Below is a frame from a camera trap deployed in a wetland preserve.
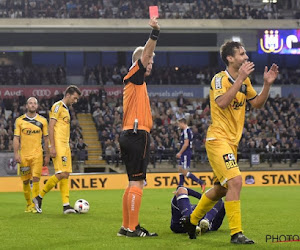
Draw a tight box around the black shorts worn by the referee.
[120,129,150,181]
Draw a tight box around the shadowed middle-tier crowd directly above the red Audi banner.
[0,65,300,86]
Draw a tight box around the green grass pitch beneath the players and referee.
[0,186,300,249]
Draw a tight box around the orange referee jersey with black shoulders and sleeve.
[123,60,153,132]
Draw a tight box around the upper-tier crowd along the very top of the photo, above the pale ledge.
[0,0,288,19]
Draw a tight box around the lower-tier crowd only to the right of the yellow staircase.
[92,93,300,163]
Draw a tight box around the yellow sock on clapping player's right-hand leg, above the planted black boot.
[224,201,243,235]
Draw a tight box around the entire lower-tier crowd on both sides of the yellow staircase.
[0,92,300,164]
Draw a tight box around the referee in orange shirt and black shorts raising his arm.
[117,17,160,237]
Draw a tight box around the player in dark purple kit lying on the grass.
[170,186,225,233]
